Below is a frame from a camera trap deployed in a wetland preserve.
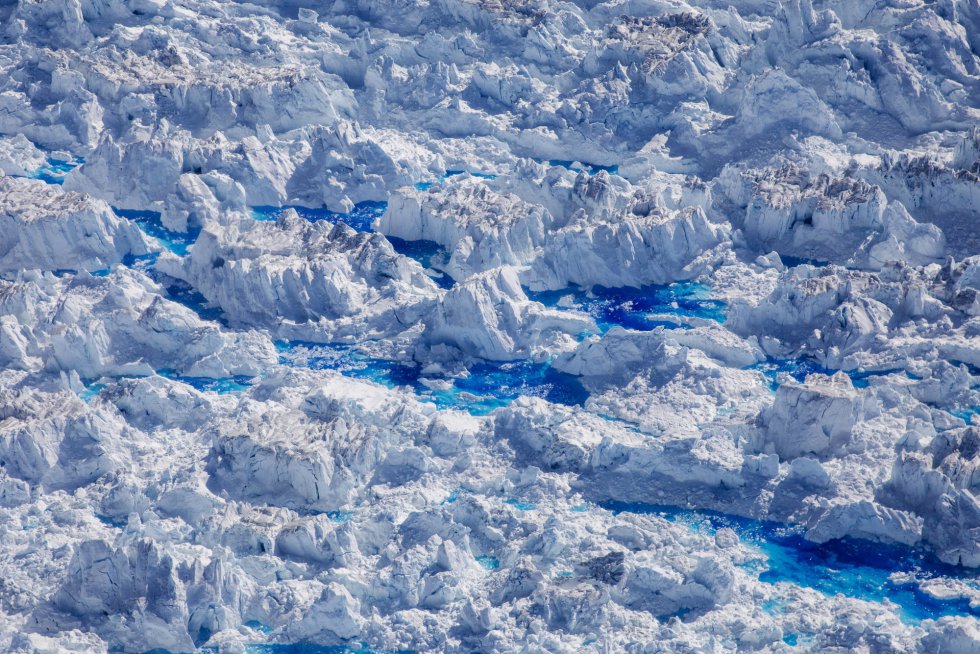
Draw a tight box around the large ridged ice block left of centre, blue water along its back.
[162,210,436,340]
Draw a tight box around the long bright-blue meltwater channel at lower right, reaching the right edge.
[601,502,980,623]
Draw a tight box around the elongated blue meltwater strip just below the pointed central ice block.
[276,341,588,415]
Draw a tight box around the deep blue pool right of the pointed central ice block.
[524,282,726,333]
